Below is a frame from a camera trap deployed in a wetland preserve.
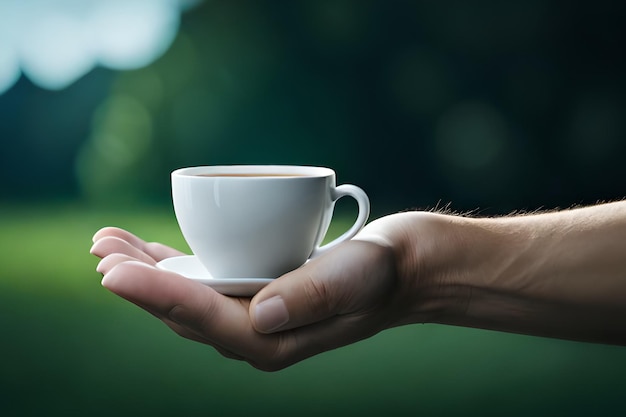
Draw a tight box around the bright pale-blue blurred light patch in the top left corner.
[0,0,196,94]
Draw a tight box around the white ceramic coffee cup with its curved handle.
[171,165,370,278]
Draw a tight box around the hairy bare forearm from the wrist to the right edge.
[403,202,626,344]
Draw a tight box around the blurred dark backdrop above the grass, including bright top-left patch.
[0,0,626,214]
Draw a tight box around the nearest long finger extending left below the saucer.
[102,261,276,357]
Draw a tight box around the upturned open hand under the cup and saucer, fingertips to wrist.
[91,216,404,370]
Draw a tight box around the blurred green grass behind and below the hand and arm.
[0,204,626,416]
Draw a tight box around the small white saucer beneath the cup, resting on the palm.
[157,255,272,297]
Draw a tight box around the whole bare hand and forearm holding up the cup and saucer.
[91,202,626,371]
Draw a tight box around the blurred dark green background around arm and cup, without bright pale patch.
[0,0,626,416]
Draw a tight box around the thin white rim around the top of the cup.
[171,165,335,179]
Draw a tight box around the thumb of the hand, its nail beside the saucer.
[249,241,387,333]
